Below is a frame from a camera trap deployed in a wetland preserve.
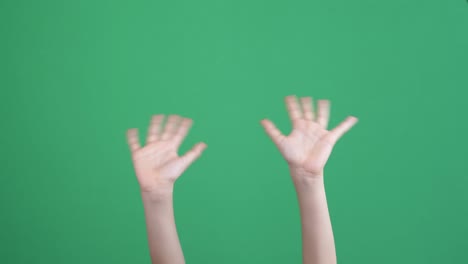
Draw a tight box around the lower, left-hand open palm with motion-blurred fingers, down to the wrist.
[127,115,206,192]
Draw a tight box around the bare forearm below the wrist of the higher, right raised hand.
[293,176,336,264]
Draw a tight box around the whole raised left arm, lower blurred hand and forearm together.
[127,115,206,264]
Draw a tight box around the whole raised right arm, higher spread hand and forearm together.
[262,96,357,264]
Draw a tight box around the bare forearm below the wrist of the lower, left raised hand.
[142,188,185,264]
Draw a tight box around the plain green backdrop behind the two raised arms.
[0,0,468,264]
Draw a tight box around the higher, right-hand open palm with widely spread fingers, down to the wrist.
[261,96,357,178]
